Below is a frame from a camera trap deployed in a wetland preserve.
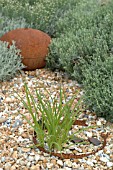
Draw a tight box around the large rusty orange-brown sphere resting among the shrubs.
[0,28,51,70]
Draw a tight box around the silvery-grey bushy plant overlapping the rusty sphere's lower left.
[0,41,24,81]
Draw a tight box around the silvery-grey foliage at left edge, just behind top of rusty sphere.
[0,14,32,37]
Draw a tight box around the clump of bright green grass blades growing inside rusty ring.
[18,83,92,151]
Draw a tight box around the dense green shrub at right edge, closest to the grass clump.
[83,54,113,122]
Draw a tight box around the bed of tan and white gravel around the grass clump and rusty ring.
[0,69,113,170]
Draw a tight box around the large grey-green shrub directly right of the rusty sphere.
[47,0,113,82]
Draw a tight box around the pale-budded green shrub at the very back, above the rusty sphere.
[0,0,78,36]
